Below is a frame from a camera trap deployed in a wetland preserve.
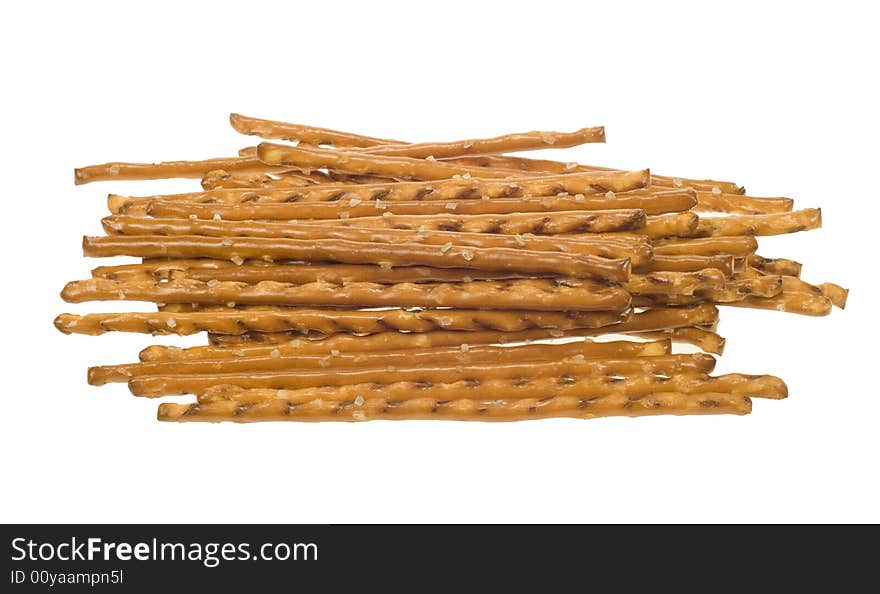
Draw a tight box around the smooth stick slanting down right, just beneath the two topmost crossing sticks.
[257,142,525,180]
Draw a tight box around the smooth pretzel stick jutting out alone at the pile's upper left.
[73,157,289,185]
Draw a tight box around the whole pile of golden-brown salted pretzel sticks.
[55,114,847,422]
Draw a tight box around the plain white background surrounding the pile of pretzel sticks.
[0,0,880,522]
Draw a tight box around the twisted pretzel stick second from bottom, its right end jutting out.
[198,373,788,404]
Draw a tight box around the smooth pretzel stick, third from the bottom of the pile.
[128,354,715,398]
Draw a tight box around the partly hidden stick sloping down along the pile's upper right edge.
[447,155,745,194]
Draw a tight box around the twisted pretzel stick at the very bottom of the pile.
[157,392,752,423]
